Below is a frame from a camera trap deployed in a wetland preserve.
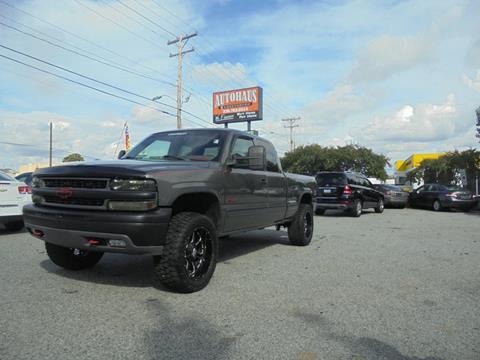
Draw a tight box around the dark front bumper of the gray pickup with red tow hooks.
[23,205,172,254]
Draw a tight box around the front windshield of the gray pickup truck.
[122,130,226,161]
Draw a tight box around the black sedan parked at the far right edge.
[408,184,478,211]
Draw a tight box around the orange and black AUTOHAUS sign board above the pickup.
[213,86,263,124]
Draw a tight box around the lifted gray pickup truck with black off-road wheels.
[23,129,315,292]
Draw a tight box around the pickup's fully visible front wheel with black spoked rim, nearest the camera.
[154,212,218,293]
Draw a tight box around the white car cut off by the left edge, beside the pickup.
[0,171,32,231]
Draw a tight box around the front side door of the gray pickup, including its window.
[225,135,267,231]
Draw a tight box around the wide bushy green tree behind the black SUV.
[282,144,389,180]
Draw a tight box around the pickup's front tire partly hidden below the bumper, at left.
[45,243,103,270]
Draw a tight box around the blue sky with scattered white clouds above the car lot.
[0,0,480,173]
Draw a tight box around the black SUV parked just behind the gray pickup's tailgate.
[315,171,384,217]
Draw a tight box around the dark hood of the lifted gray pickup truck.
[34,160,216,178]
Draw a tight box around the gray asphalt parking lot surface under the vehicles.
[0,209,480,360]
